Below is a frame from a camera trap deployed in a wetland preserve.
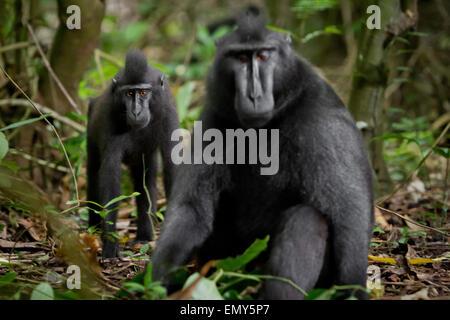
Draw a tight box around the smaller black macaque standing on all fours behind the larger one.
[87,50,178,258]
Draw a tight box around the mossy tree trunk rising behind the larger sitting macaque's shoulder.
[349,0,418,196]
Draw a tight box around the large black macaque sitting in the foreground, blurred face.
[153,10,373,299]
